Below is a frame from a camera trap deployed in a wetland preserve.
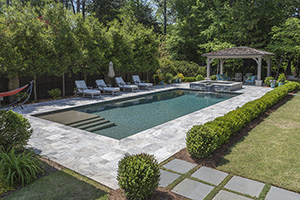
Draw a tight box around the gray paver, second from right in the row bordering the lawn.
[225,176,265,197]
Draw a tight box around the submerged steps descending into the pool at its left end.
[66,116,115,132]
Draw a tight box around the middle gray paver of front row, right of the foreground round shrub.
[172,179,214,200]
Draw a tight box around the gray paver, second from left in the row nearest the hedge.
[192,167,228,185]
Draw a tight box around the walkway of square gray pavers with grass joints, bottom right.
[159,159,300,200]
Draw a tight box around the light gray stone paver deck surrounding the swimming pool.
[15,83,271,189]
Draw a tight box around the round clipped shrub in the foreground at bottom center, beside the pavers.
[117,153,160,200]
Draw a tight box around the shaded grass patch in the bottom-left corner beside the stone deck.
[7,169,109,200]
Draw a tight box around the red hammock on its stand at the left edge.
[0,81,34,109]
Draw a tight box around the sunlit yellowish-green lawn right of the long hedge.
[217,96,300,192]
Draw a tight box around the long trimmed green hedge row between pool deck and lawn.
[186,82,300,158]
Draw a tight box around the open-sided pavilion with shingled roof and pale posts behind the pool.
[202,47,275,80]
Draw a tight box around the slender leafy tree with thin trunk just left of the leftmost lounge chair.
[40,3,79,96]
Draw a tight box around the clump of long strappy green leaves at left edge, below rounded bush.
[0,148,43,186]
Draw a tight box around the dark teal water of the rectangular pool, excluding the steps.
[76,90,237,139]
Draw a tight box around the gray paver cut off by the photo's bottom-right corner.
[266,186,300,200]
